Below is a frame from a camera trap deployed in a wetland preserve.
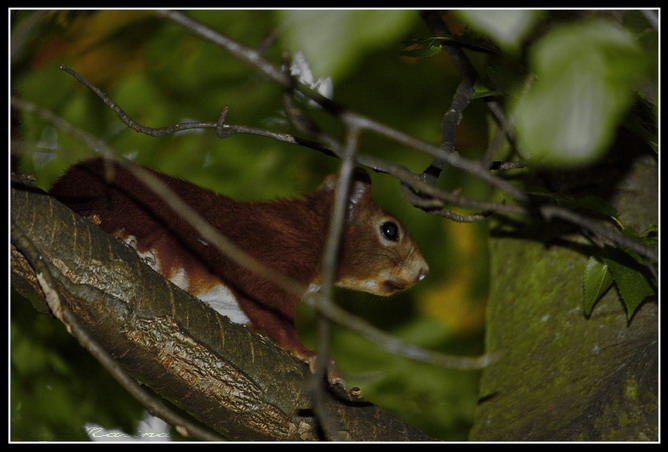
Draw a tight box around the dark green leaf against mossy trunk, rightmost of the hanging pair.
[603,249,656,319]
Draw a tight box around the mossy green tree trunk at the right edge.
[470,144,658,441]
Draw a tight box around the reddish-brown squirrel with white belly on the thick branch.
[49,158,429,383]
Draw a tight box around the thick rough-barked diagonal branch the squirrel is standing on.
[11,180,429,441]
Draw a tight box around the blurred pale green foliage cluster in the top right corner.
[458,11,658,167]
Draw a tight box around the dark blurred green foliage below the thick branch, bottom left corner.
[9,293,143,441]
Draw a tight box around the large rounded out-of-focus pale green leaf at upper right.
[513,20,649,166]
